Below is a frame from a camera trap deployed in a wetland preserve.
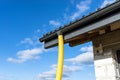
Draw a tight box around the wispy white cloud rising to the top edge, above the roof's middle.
[71,0,91,20]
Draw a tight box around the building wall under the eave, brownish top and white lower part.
[92,30,120,80]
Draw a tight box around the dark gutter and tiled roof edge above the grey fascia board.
[39,1,120,42]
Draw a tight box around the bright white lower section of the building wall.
[94,58,116,80]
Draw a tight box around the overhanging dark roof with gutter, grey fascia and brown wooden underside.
[40,1,120,48]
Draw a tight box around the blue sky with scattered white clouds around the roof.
[0,0,115,80]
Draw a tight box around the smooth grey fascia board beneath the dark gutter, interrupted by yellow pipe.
[44,11,120,49]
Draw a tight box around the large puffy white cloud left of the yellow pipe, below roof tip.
[7,48,45,63]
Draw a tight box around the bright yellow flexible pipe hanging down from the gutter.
[56,35,64,80]
